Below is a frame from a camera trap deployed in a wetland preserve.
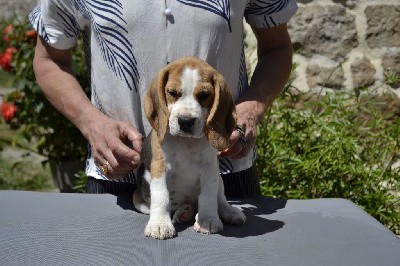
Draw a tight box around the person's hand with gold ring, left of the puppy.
[88,113,143,179]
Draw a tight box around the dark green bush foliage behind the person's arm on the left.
[0,19,89,161]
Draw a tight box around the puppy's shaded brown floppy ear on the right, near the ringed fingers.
[205,73,236,151]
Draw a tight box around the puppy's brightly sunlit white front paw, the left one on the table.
[144,217,176,239]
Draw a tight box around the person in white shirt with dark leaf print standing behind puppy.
[30,0,297,197]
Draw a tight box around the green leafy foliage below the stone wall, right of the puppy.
[257,90,400,234]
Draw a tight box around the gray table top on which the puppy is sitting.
[0,191,400,265]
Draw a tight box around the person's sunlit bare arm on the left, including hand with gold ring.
[33,37,143,178]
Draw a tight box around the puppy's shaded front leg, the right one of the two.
[193,161,223,234]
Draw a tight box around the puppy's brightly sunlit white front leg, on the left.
[145,171,176,239]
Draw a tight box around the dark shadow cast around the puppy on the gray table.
[117,195,287,238]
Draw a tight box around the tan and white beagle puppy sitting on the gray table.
[133,57,246,239]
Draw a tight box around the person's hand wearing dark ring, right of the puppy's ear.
[219,101,258,159]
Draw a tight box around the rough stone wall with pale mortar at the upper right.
[246,0,400,95]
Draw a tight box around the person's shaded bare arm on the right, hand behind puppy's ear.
[220,24,292,159]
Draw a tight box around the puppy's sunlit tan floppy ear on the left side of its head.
[144,67,169,143]
